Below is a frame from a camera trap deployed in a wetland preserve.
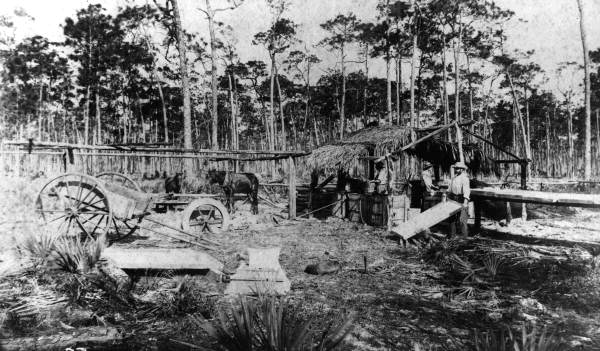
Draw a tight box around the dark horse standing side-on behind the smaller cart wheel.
[206,169,258,214]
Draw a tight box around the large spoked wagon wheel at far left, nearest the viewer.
[36,173,113,239]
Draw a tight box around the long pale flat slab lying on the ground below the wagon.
[102,247,223,273]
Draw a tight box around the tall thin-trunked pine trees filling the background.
[0,0,600,178]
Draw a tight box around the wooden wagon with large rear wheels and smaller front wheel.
[36,173,230,243]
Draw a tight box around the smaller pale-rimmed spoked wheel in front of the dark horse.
[181,199,231,234]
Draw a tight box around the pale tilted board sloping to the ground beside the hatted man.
[391,200,462,240]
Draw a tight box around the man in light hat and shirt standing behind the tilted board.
[448,162,471,237]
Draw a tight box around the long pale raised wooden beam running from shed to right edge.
[471,188,600,207]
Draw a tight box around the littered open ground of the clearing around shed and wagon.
[0,178,600,350]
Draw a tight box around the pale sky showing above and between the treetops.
[0,0,600,92]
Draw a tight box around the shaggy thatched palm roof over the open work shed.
[307,126,497,174]
